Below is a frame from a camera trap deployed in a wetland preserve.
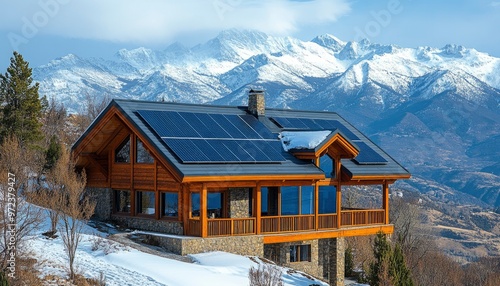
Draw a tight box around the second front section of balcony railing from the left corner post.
[261,215,314,233]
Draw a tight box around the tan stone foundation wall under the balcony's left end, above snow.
[146,232,264,257]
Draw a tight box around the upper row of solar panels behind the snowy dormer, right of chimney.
[273,117,359,140]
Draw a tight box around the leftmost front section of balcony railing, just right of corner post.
[208,218,255,236]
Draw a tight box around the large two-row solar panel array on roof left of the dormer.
[137,110,286,163]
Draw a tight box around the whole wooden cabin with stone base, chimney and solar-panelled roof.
[72,90,410,285]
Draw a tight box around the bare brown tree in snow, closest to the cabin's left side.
[47,150,95,280]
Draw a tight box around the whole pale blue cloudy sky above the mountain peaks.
[0,0,500,69]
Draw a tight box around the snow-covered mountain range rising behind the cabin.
[34,30,500,207]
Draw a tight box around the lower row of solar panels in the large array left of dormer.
[163,138,286,163]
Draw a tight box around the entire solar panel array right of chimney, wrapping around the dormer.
[272,117,388,165]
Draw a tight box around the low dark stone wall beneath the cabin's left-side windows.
[111,215,184,235]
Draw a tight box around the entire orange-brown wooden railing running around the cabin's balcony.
[187,209,385,237]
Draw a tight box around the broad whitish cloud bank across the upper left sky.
[0,0,350,43]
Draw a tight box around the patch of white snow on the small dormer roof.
[279,130,332,151]
